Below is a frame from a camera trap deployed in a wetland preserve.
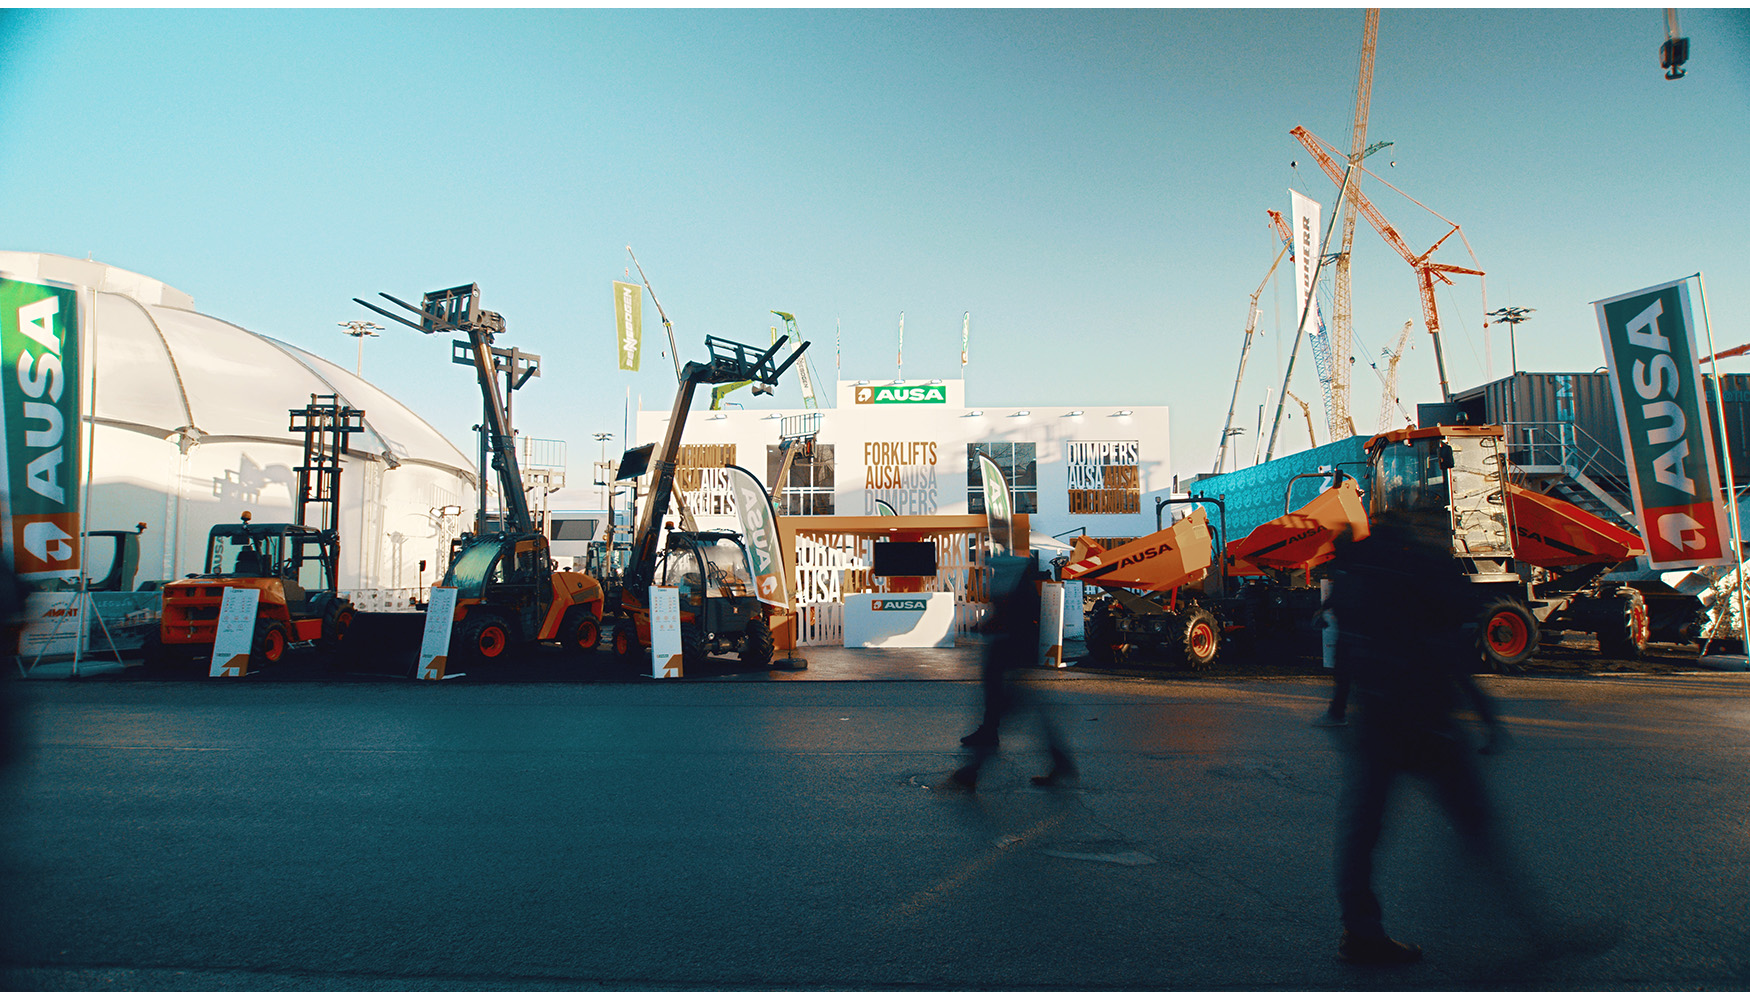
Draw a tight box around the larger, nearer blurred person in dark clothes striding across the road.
[1330,524,1537,965]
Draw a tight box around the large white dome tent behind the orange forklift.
[0,250,476,592]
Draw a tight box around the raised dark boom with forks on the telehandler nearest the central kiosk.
[620,336,809,592]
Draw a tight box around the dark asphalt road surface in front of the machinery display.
[0,674,1750,989]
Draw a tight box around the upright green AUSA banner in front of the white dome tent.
[0,278,84,578]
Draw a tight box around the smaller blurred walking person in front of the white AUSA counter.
[949,555,1076,792]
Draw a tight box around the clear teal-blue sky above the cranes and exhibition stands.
[0,9,1750,482]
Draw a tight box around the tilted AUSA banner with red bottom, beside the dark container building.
[1593,282,1731,569]
